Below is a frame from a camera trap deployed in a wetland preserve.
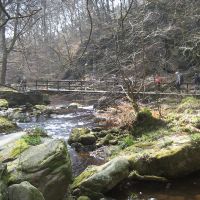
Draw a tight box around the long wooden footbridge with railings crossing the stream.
[17,80,200,97]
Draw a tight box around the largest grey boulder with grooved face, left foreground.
[7,140,72,200]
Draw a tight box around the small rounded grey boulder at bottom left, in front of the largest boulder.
[8,181,44,200]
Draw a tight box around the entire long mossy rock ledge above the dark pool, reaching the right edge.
[72,133,200,200]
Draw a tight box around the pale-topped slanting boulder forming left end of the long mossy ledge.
[72,157,129,200]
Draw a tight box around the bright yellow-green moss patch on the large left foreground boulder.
[10,139,29,158]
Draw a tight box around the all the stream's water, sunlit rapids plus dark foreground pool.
[1,106,200,200]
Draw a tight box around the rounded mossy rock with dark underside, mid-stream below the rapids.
[68,128,96,145]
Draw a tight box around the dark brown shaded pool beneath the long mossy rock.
[109,172,200,200]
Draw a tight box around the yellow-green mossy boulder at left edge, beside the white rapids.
[0,117,19,133]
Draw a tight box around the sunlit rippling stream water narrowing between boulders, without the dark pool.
[18,106,103,175]
